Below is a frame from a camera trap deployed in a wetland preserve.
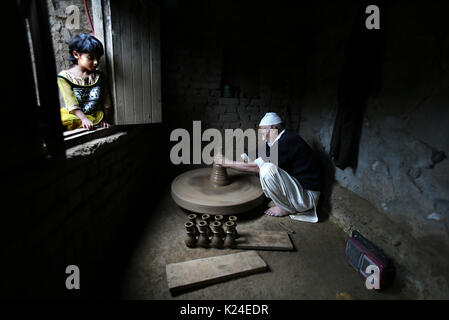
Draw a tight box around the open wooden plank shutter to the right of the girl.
[92,0,162,125]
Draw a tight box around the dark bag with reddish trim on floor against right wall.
[345,230,395,289]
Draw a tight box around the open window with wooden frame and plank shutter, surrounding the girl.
[18,0,162,151]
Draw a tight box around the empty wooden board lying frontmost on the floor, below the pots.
[166,251,268,293]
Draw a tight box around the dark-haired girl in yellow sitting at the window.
[58,33,111,130]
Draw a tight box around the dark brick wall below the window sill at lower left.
[0,126,161,297]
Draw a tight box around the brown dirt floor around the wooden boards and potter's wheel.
[116,188,415,300]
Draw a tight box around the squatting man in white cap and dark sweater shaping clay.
[215,112,322,222]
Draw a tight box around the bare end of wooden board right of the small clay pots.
[236,227,294,251]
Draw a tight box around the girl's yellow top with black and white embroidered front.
[58,70,111,114]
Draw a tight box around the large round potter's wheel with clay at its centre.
[171,164,264,215]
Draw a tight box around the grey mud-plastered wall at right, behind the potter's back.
[300,1,449,297]
